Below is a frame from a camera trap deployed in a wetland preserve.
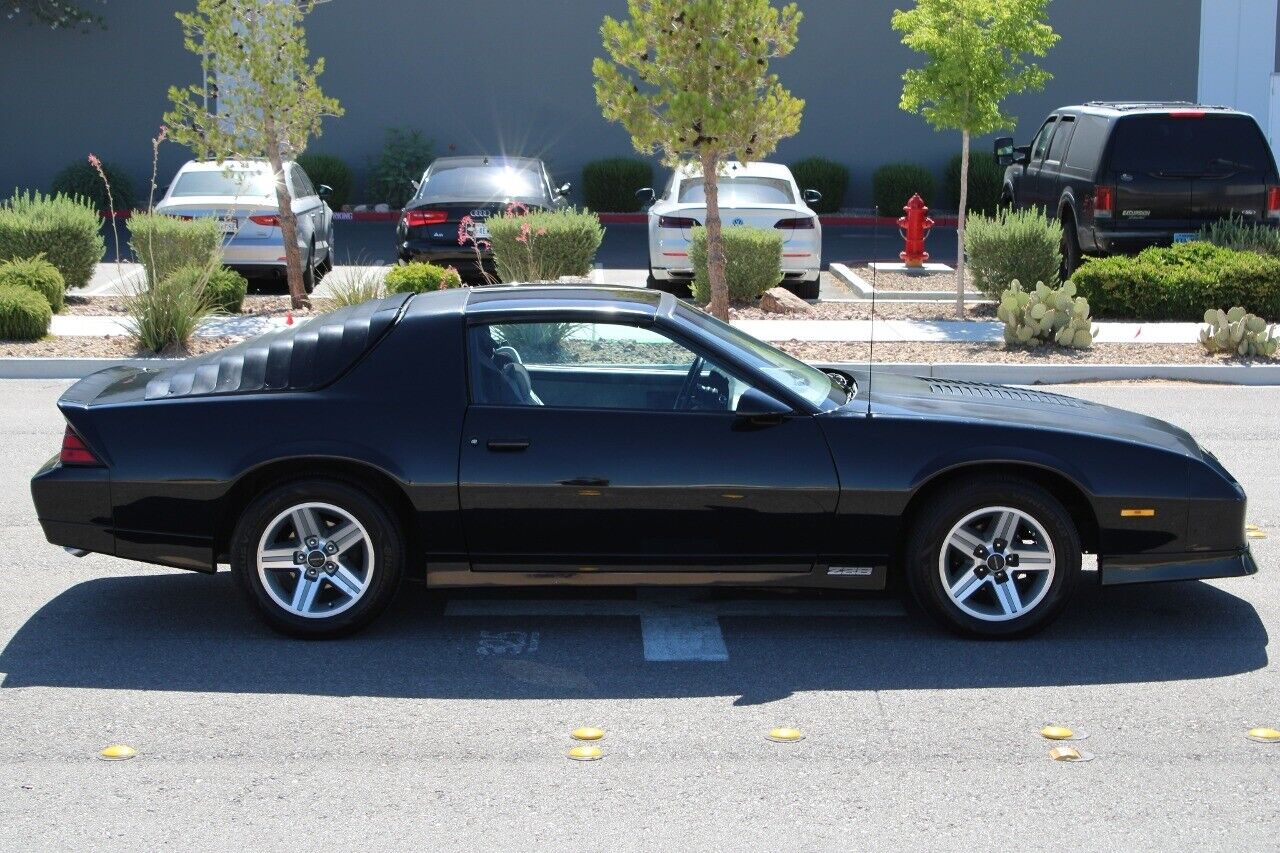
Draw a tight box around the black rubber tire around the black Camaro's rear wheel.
[230,479,404,639]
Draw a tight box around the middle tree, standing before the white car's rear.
[591,0,804,320]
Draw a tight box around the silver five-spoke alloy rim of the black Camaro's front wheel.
[938,506,1057,622]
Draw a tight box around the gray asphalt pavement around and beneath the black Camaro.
[0,380,1280,850]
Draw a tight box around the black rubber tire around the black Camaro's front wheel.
[904,476,1080,638]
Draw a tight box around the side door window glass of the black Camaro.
[467,323,749,411]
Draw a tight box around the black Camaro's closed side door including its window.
[458,320,838,573]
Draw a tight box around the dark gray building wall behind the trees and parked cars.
[0,0,1201,204]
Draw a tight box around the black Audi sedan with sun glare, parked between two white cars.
[396,156,570,280]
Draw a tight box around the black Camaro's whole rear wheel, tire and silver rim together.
[232,479,404,639]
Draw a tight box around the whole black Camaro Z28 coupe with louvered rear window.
[32,286,1257,637]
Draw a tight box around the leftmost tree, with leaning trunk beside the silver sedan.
[164,0,342,309]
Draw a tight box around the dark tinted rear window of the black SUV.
[1111,115,1272,175]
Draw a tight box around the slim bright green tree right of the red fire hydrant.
[893,0,1059,318]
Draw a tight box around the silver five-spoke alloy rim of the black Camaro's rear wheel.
[257,502,374,619]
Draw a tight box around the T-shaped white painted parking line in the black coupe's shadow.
[444,589,906,661]
